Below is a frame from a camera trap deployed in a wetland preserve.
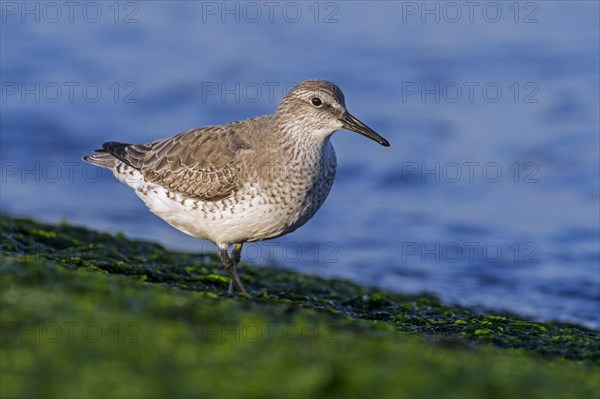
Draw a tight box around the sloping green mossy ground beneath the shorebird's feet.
[0,217,600,397]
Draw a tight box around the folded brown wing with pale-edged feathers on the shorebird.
[102,118,265,201]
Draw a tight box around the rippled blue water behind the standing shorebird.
[0,1,600,329]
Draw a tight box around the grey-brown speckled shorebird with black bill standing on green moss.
[83,80,389,296]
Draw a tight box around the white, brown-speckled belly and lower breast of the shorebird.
[113,141,336,245]
